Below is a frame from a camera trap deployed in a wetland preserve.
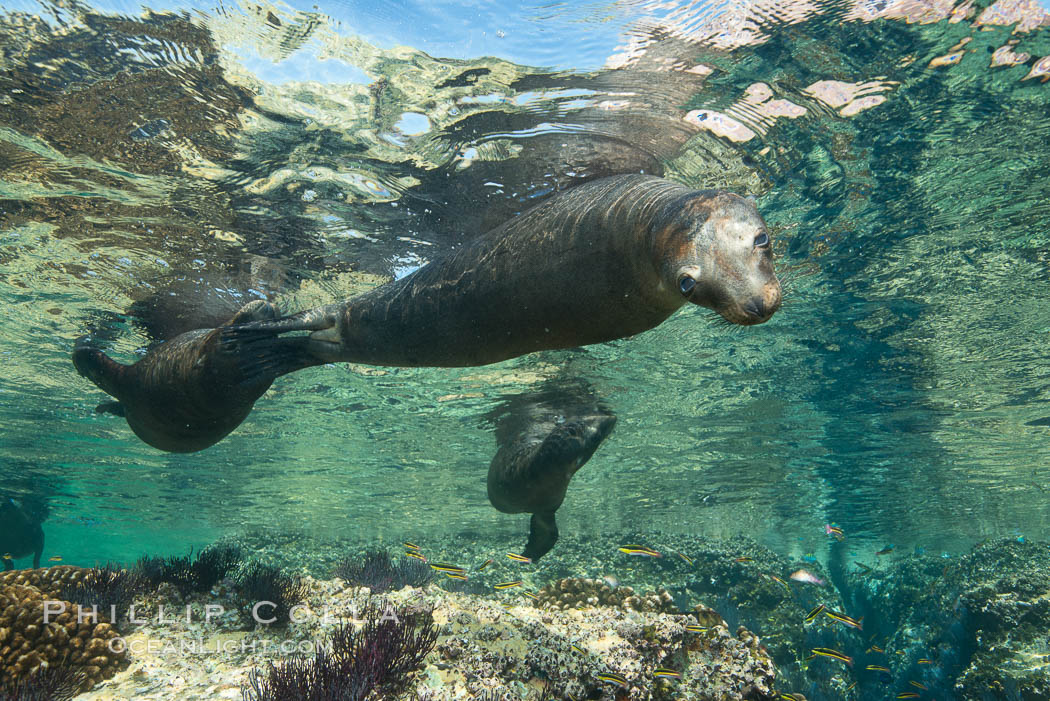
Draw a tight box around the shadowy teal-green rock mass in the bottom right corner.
[857,538,1050,701]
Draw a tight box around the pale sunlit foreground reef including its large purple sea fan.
[59,577,775,701]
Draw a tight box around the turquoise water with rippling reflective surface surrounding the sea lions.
[0,2,1050,696]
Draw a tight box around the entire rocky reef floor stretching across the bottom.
[0,536,1050,701]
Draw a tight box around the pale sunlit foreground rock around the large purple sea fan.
[59,577,776,701]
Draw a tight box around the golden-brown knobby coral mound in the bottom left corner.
[0,570,125,688]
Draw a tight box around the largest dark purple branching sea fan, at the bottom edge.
[243,602,438,701]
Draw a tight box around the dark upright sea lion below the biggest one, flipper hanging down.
[488,384,616,562]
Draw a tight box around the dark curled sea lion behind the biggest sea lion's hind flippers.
[72,300,302,452]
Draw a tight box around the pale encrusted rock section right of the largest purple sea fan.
[435,587,775,701]
